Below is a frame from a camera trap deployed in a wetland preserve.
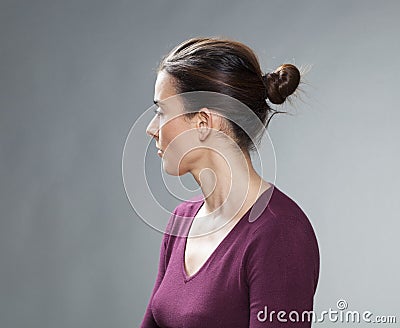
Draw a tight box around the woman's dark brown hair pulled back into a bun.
[157,37,300,150]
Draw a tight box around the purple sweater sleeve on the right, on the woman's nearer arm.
[246,218,319,328]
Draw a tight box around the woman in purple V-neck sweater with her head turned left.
[141,38,319,328]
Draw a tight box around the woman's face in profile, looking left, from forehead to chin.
[146,71,201,175]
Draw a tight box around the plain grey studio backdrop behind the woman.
[0,0,400,328]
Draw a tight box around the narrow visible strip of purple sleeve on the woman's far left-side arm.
[140,209,176,328]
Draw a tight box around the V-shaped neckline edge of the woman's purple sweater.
[181,182,276,283]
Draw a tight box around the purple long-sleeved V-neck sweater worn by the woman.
[140,183,319,328]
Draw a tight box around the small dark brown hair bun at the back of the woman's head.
[263,64,300,105]
